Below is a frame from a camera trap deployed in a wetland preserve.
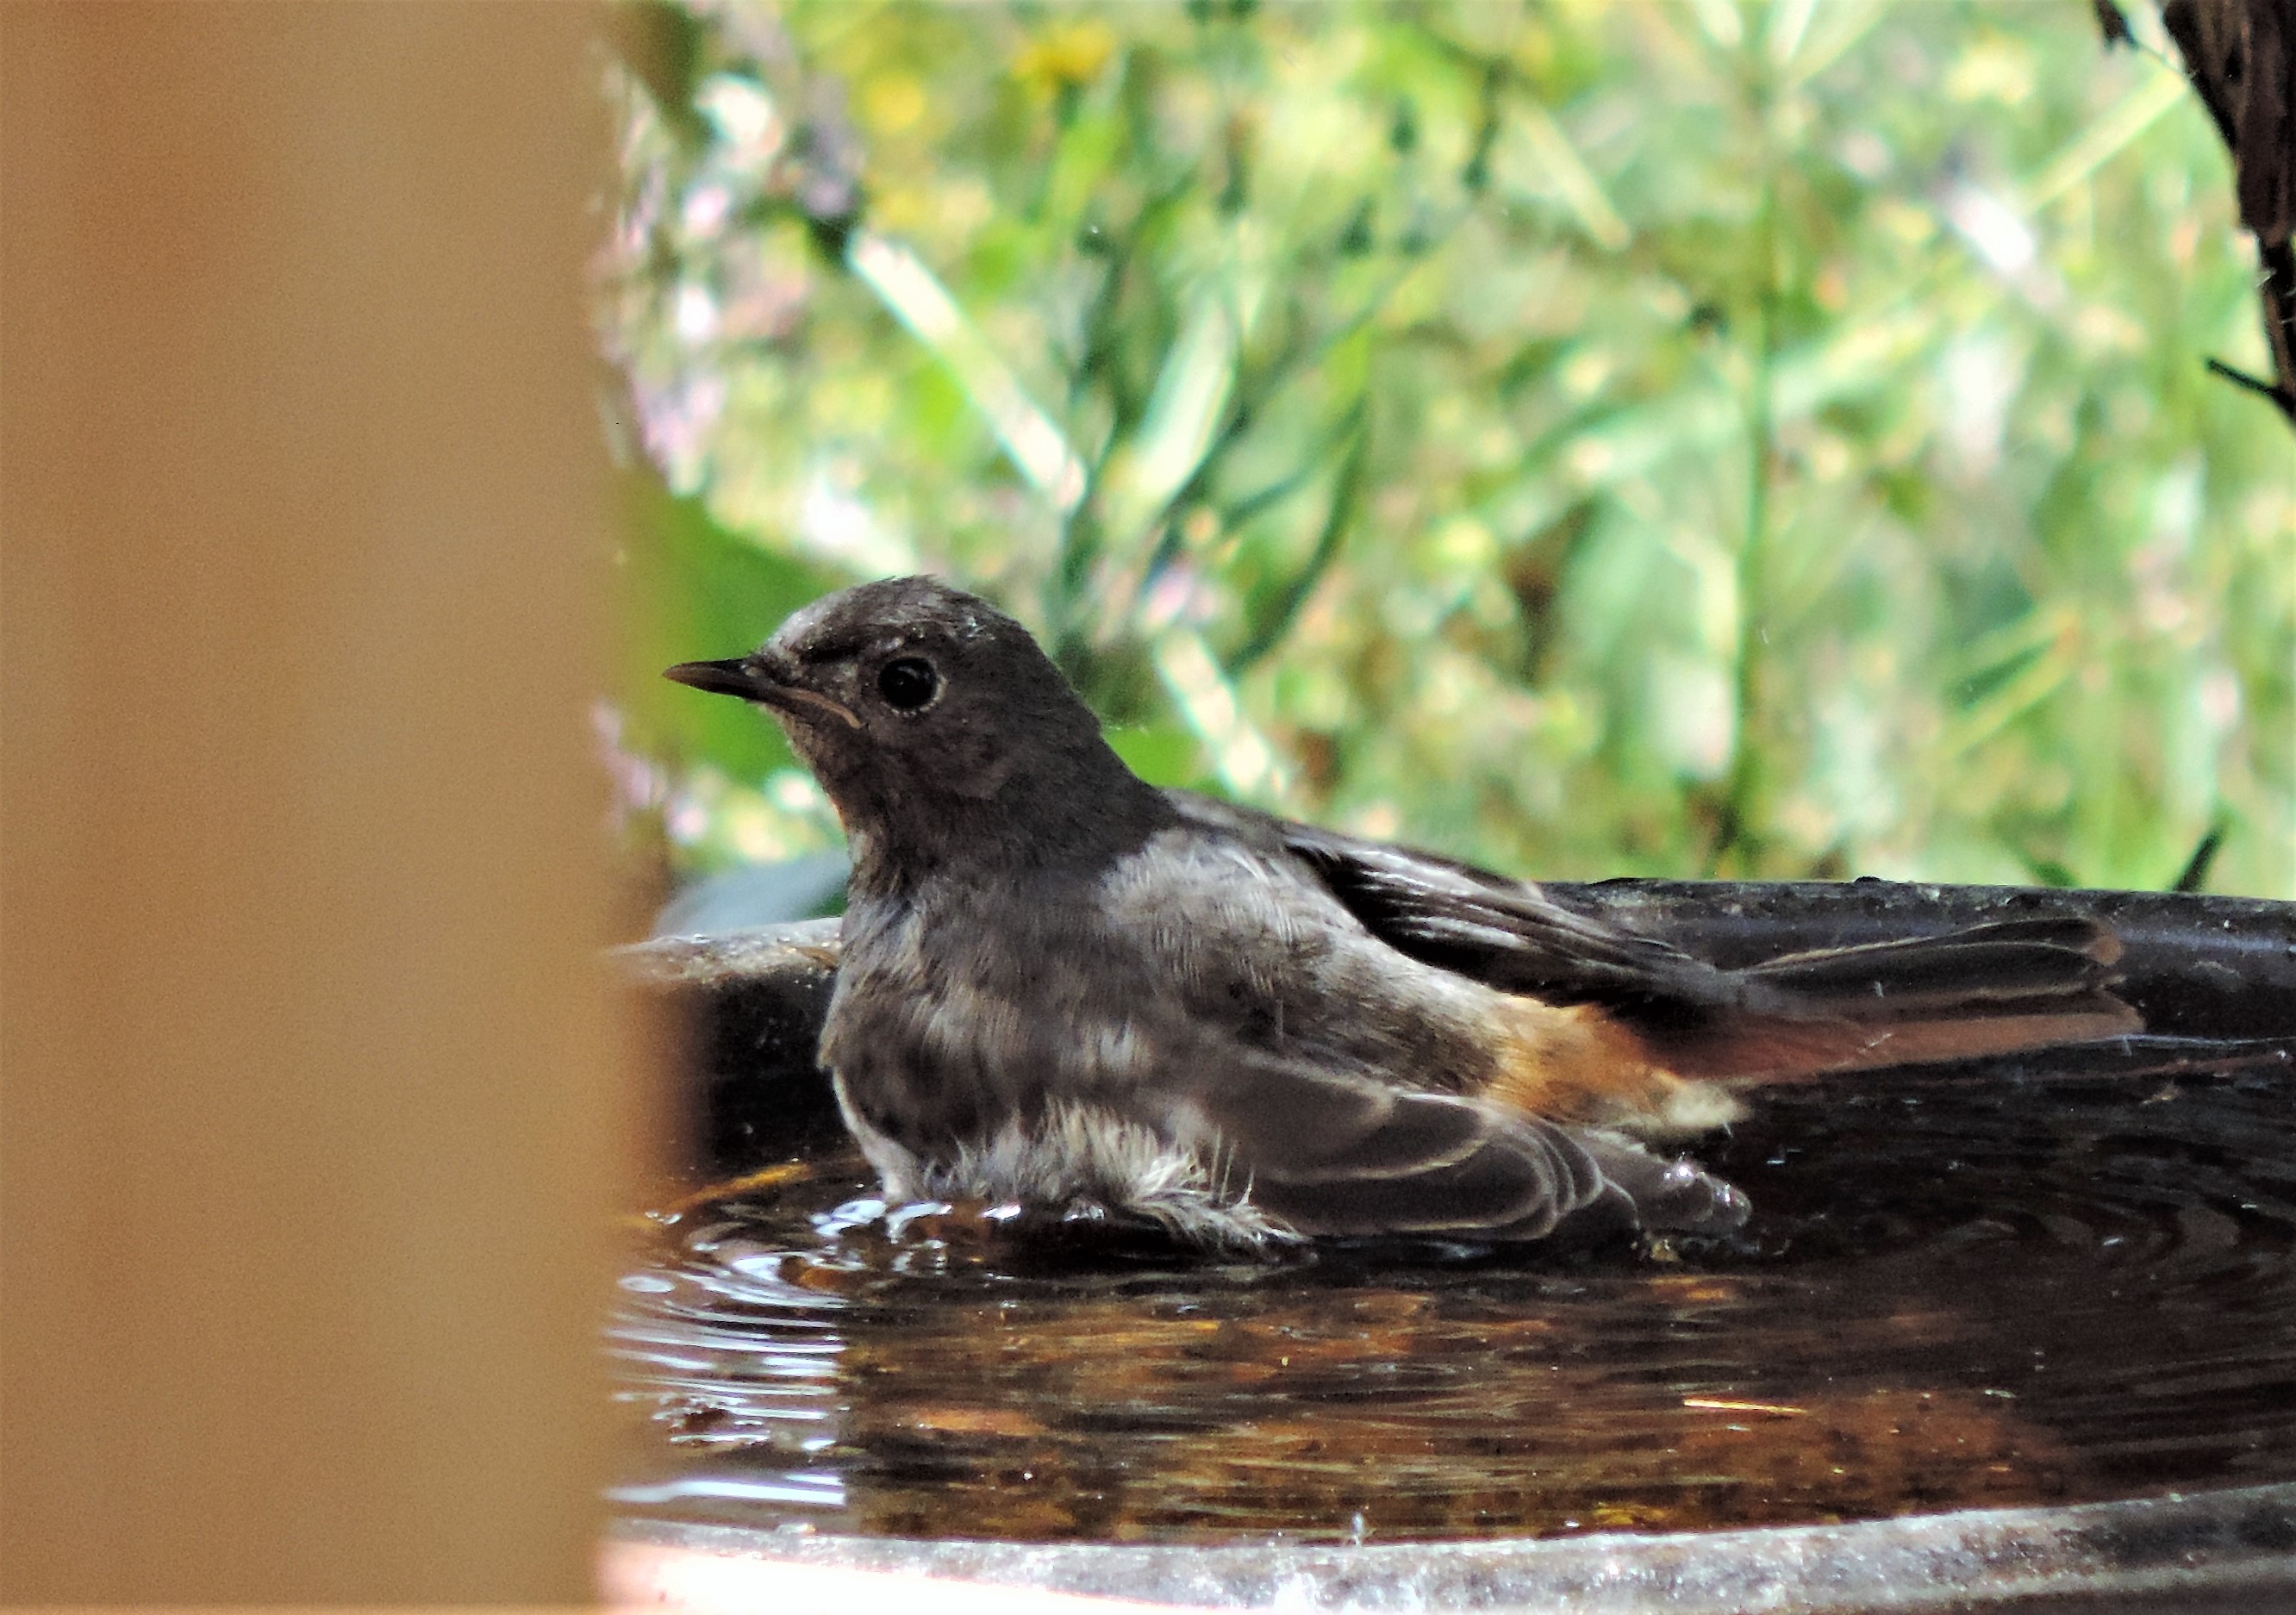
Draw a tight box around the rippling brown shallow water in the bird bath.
[608,1066,2296,1542]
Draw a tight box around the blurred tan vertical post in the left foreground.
[0,4,636,1604]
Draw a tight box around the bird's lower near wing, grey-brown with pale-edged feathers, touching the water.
[1192,1057,1745,1238]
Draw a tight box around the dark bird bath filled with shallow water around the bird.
[608,882,2296,1611]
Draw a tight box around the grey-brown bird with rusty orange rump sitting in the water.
[666,577,2143,1256]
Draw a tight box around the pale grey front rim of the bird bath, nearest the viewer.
[604,1484,2296,1615]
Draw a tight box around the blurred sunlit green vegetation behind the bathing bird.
[602,0,2296,914]
